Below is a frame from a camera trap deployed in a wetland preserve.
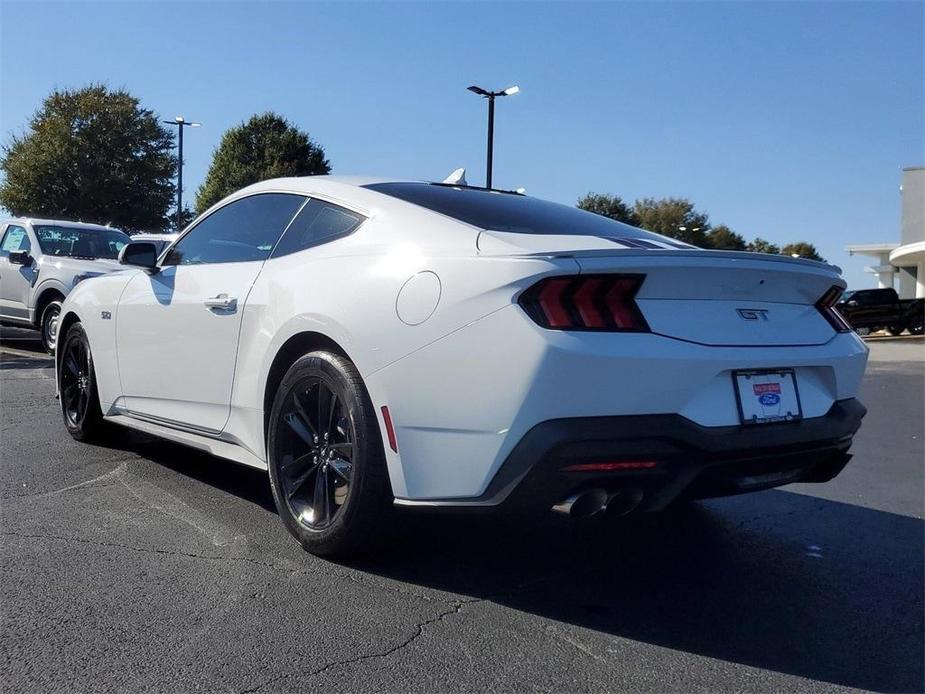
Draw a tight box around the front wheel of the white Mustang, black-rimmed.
[58,323,108,441]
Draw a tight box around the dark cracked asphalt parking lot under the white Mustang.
[0,329,925,692]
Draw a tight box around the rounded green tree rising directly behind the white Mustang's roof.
[196,111,331,213]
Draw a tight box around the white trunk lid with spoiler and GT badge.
[479,232,845,347]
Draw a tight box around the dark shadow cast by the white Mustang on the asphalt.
[352,491,925,691]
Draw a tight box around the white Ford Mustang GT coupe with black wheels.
[57,176,867,554]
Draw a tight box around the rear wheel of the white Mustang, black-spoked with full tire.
[267,352,392,556]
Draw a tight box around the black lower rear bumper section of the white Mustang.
[396,398,867,511]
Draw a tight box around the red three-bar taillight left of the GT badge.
[519,275,649,332]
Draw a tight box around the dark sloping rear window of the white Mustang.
[364,183,691,248]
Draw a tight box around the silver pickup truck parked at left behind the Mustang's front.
[0,219,130,352]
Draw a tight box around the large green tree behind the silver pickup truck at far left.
[0,85,177,230]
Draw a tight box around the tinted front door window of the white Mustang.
[163,193,305,265]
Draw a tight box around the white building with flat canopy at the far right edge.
[845,166,925,299]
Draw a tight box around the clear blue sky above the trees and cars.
[0,0,925,286]
